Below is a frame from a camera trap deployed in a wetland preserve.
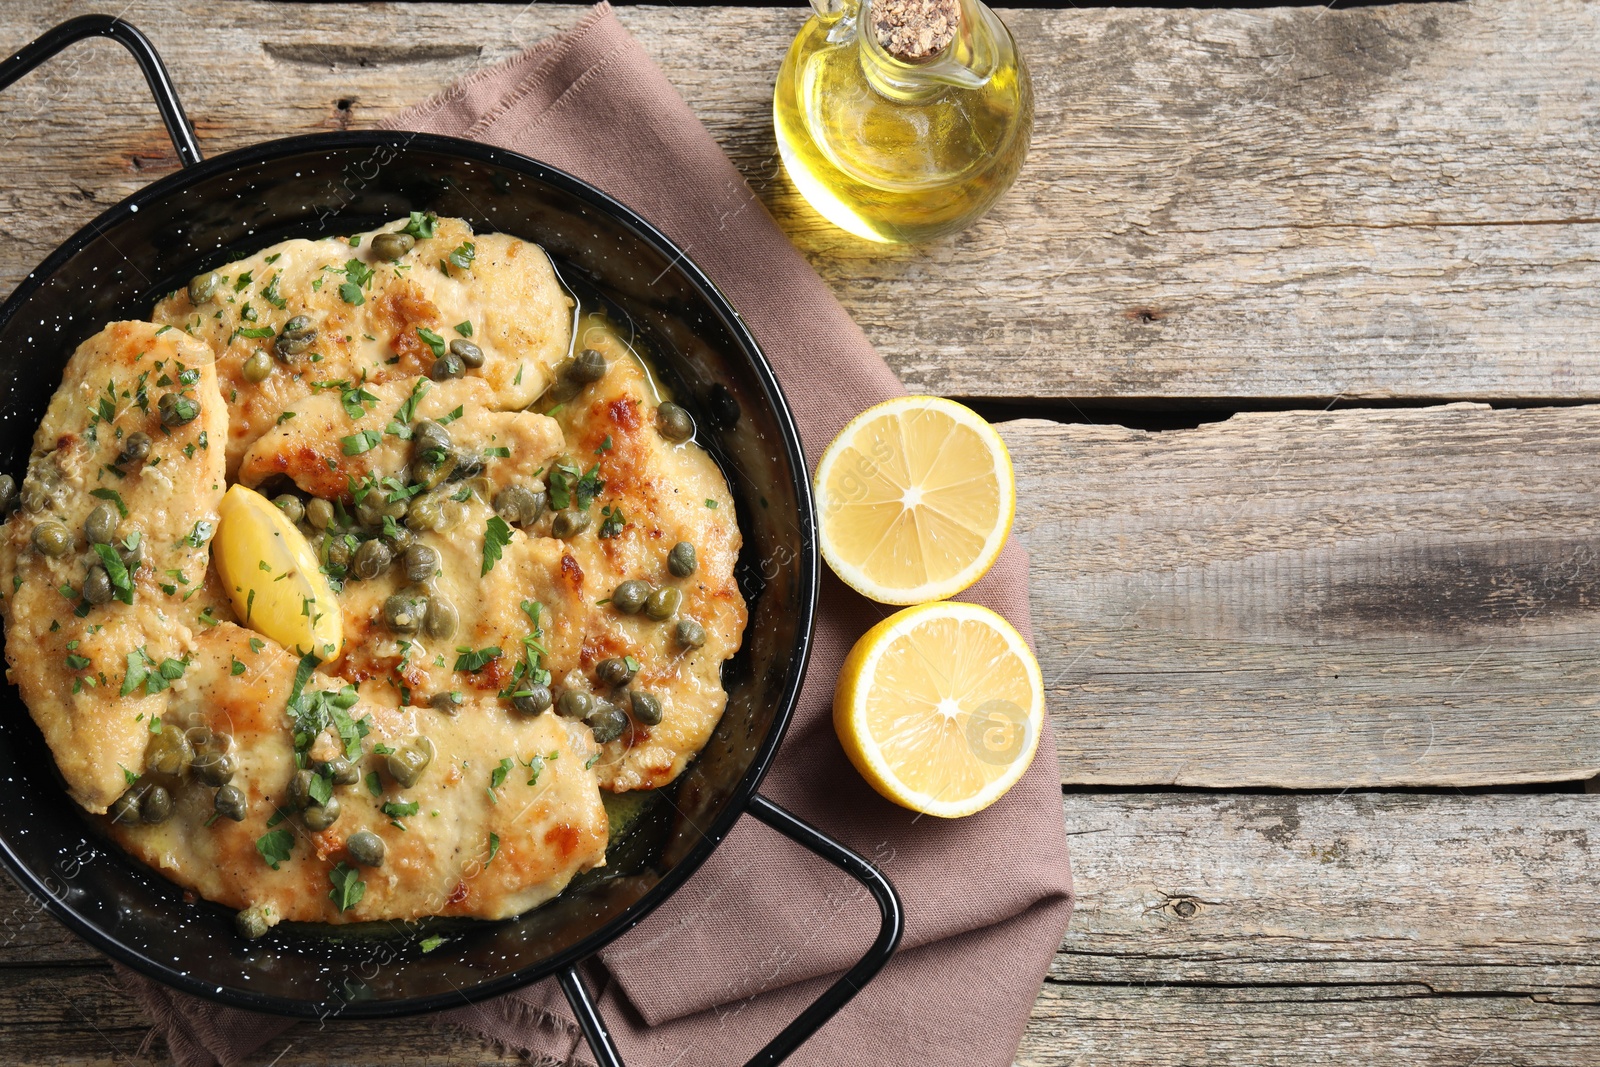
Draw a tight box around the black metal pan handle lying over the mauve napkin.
[557,793,906,1067]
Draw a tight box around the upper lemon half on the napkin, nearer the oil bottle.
[816,397,1016,605]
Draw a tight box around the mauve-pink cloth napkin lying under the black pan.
[120,3,1072,1067]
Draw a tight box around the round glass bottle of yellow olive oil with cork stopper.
[773,0,1034,242]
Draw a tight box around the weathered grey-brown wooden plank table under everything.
[0,0,1600,1067]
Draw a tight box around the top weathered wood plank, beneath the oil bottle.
[0,0,1600,403]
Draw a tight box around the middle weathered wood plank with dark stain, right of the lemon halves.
[1002,405,1600,789]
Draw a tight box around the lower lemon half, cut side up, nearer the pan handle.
[834,601,1045,819]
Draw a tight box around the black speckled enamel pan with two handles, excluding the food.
[0,14,902,1067]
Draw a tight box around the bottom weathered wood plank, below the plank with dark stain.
[12,793,1600,1067]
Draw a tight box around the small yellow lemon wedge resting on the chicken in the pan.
[211,485,344,662]
